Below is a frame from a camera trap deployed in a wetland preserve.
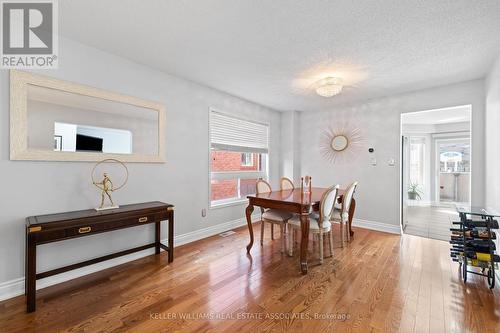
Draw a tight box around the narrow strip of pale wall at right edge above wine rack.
[485,53,500,212]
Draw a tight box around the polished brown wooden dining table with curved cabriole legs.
[246,187,356,274]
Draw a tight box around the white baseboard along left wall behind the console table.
[0,215,260,301]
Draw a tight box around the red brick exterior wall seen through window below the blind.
[210,151,260,200]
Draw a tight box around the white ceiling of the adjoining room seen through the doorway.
[401,105,471,125]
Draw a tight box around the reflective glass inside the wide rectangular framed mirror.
[27,85,159,155]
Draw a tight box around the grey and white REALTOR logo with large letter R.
[0,0,58,69]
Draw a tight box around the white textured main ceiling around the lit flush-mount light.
[59,0,500,111]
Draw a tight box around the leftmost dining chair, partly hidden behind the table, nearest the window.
[256,179,293,253]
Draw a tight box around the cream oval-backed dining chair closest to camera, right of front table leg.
[288,185,339,264]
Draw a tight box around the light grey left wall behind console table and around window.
[0,38,281,290]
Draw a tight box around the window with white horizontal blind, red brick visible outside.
[210,110,269,207]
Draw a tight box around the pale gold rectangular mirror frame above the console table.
[10,70,165,163]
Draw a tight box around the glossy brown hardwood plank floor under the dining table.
[0,224,500,333]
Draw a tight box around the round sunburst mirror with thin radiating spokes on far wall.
[320,123,364,163]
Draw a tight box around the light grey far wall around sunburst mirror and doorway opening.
[292,80,484,225]
